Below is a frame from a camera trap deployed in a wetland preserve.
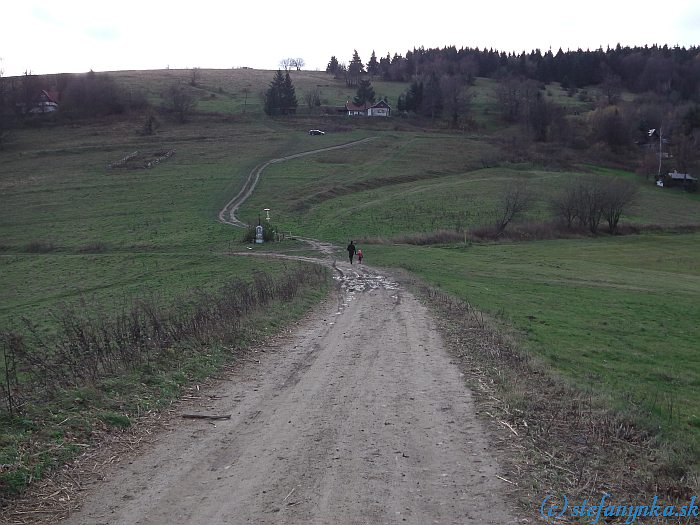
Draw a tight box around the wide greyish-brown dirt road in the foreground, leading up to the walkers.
[64,263,518,525]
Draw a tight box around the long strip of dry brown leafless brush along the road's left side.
[0,265,326,412]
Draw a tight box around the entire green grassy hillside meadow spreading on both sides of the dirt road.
[0,65,700,512]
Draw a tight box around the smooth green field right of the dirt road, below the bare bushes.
[364,234,700,458]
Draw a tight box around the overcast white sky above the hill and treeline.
[0,0,700,76]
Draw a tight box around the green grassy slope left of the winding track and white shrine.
[0,116,370,326]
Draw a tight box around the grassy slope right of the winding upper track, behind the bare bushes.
[240,132,700,243]
